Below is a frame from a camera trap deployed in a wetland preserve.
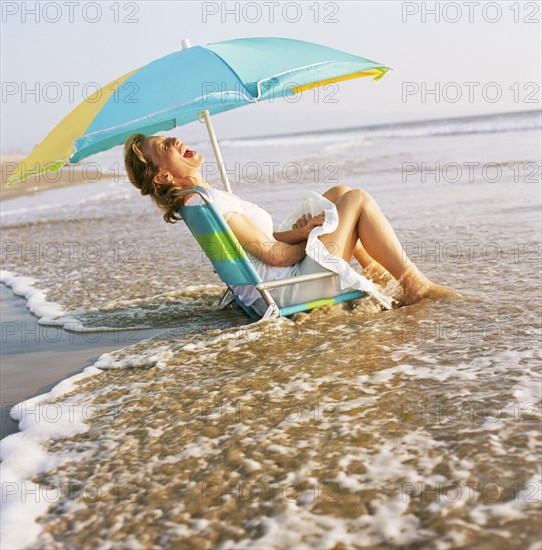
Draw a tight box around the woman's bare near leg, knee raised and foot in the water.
[320,189,460,304]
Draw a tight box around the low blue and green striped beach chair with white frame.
[175,186,376,320]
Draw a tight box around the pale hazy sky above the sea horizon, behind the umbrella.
[0,0,542,154]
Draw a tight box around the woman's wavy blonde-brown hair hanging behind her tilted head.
[124,134,183,223]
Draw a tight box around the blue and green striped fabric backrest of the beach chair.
[179,187,262,285]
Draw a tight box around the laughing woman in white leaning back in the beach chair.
[124,134,455,314]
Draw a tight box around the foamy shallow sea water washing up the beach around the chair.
[1,112,542,550]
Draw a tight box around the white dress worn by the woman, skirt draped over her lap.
[186,187,392,315]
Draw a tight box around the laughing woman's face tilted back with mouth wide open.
[141,136,204,185]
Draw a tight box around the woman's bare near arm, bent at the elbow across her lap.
[228,212,305,267]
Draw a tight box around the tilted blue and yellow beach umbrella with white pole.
[8,37,388,191]
